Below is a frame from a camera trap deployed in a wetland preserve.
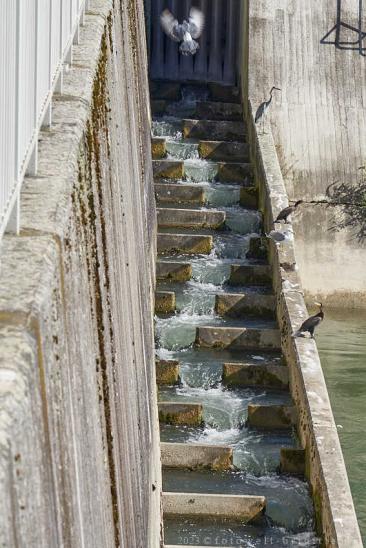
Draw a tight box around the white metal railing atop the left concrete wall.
[0,0,88,238]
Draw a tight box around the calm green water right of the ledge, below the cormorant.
[317,310,366,542]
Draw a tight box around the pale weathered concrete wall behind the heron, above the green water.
[243,0,366,307]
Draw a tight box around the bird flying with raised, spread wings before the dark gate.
[160,8,205,55]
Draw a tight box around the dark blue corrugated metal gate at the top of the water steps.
[150,0,241,84]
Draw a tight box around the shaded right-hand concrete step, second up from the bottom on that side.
[247,403,297,430]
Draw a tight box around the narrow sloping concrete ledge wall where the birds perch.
[244,109,362,548]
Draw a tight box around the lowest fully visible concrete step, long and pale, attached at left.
[163,492,266,523]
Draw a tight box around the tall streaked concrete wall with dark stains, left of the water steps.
[0,0,161,548]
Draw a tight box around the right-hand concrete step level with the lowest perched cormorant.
[215,293,276,318]
